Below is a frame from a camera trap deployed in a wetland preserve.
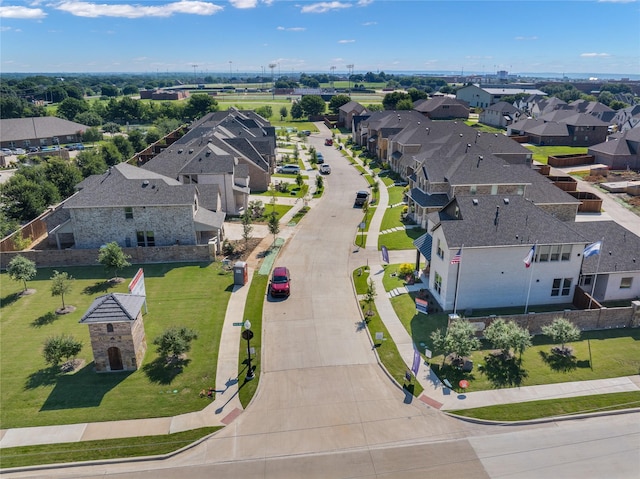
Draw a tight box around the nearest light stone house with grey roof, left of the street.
[46,163,225,248]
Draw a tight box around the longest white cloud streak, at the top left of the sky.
[56,0,223,18]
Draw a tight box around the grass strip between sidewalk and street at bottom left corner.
[0,427,221,469]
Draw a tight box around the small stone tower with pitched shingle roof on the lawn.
[80,293,147,372]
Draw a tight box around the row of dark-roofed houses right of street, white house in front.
[353,107,640,311]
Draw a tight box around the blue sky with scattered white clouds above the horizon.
[0,0,640,75]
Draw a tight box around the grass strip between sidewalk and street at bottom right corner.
[448,391,640,421]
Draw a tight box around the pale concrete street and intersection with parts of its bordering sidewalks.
[2,124,640,479]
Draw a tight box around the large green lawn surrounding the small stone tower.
[0,263,233,428]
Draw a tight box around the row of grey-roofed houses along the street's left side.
[46,110,275,250]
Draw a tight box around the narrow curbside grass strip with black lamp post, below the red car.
[238,271,269,408]
